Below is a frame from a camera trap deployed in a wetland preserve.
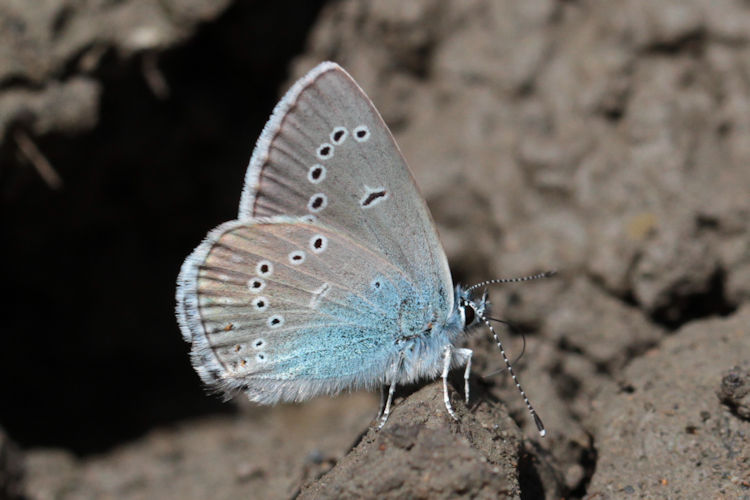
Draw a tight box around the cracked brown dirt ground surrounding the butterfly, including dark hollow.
[0,0,750,500]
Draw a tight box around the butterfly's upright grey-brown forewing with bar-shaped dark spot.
[239,62,453,314]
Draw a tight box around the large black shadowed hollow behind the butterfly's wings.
[0,0,322,454]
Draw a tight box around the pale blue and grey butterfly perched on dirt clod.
[177,62,545,435]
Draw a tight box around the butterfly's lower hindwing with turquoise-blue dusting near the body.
[178,217,436,404]
